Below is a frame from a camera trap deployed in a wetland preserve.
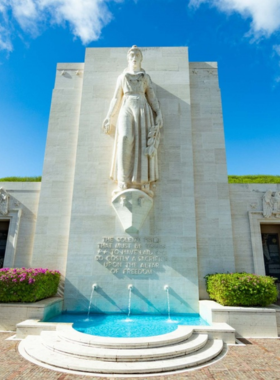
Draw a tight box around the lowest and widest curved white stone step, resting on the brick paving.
[19,336,223,374]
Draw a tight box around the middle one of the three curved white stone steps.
[41,332,208,362]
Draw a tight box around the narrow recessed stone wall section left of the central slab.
[32,63,84,276]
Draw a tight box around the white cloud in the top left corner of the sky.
[0,0,117,50]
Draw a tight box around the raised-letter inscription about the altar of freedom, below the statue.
[95,237,167,276]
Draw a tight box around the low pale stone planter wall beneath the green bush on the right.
[199,300,280,338]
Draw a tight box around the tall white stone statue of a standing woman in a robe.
[103,45,163,196]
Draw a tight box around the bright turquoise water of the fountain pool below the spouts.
[46,313,208,338]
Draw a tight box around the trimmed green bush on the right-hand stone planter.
[205,273,277,306]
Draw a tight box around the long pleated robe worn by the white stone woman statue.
[110,70,159,188]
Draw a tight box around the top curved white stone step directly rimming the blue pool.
[57,326,193,349]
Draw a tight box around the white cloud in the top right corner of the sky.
[189,0,280,37]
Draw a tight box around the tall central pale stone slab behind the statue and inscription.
[64,47,198,314]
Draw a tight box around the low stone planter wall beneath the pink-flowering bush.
[0,297,63,331]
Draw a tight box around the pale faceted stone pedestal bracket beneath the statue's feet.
[112,189,153,233]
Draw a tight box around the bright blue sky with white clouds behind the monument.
[0,0,280,178]
